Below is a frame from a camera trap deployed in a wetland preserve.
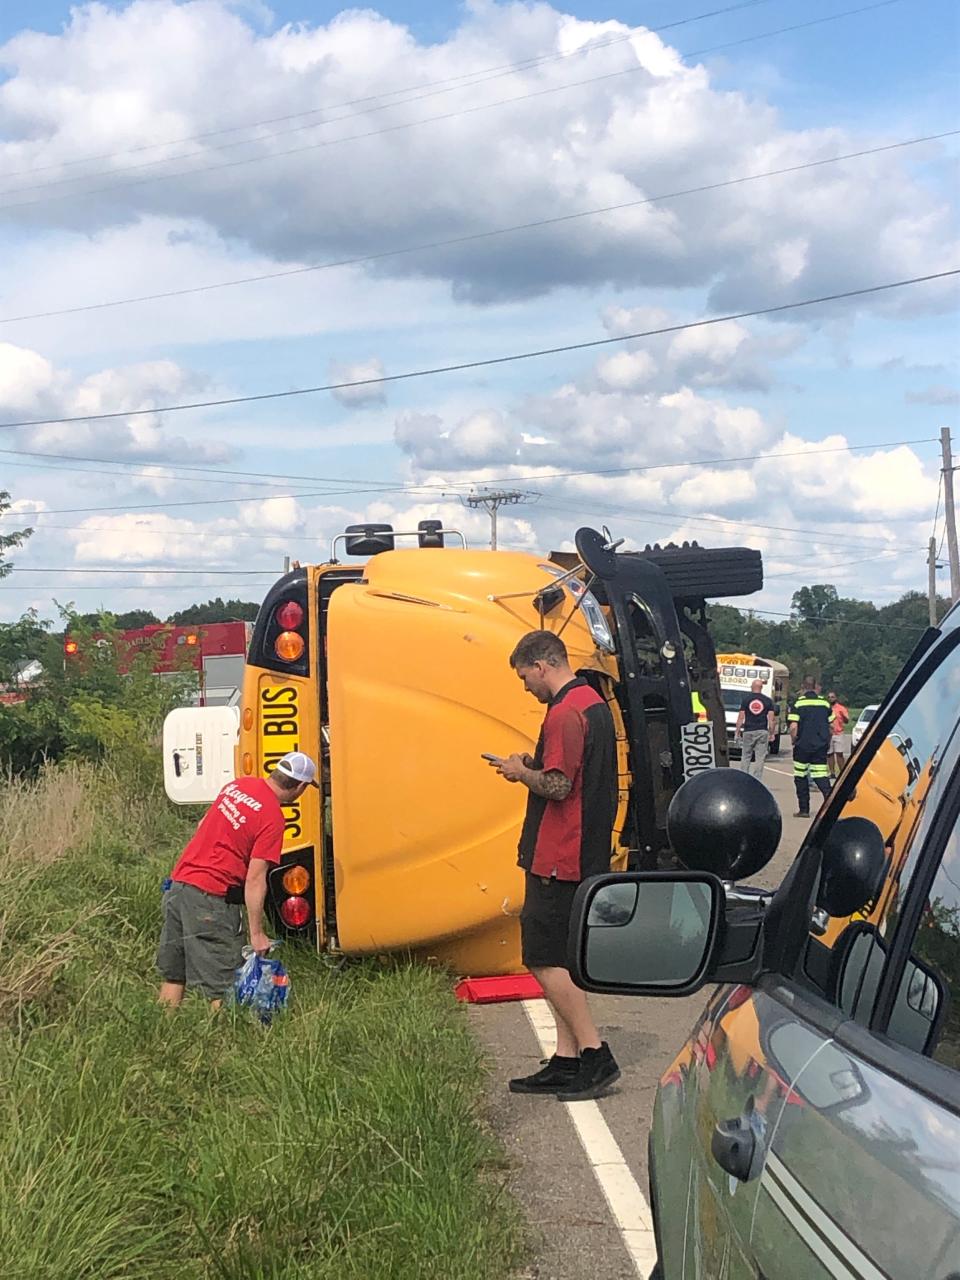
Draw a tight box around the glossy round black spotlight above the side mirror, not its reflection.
[667,769,783,881]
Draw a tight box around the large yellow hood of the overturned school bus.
[327,550,628,974]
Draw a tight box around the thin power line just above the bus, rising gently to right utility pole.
[8,436,936,520]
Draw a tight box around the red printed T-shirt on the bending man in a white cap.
[172,778,283,897]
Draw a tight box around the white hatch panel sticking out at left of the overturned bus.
[164,707,239,804]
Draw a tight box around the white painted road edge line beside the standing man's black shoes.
[524,1000,657,1280]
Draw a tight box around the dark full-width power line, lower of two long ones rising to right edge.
[0,268,960,435]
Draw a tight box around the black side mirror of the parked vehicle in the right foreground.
[568,872,724,996]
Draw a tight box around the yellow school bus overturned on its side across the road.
[164,521,762,975]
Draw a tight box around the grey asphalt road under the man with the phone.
[471,754,819,1280]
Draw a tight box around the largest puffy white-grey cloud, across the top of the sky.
[0,0,951,308]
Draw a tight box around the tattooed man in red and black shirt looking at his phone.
[490,631,620,1102]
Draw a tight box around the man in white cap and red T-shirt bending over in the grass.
[156,751,317,1005]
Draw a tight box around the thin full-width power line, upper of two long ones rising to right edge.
[0,129,960,324]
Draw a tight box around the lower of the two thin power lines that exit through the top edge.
[0,0,902,210]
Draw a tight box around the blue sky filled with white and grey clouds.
[0,0,960,621]
